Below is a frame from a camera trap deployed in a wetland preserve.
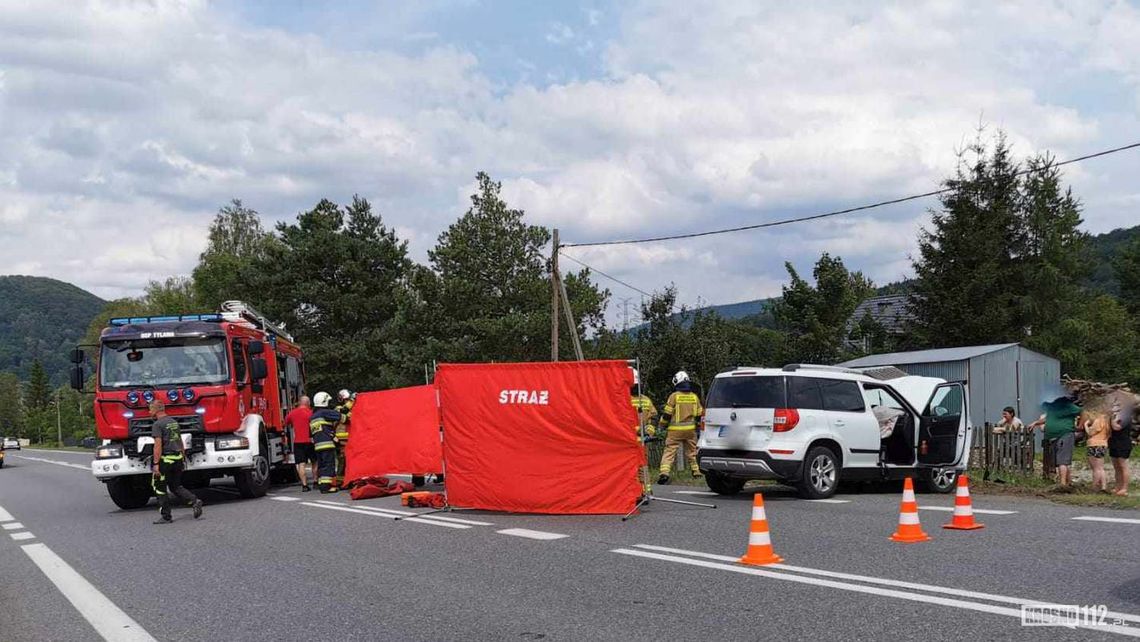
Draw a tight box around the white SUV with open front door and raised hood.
[697,365,972,499]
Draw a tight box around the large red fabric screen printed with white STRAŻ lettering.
[435,361,644,514]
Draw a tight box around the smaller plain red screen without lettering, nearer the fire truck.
[344,385,443,482]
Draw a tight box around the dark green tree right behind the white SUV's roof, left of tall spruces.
[773,253,874,364]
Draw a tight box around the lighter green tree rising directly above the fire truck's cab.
[193,198,274,310]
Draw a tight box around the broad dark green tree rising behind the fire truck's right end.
[247,196,412,391]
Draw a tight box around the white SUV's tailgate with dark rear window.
[705,371,787,450]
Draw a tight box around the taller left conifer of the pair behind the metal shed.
[909,133,1024,348]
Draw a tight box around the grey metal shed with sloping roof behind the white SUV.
[840,343,1064,425]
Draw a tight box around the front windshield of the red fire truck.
[99,336,229,388]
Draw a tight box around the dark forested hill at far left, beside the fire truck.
[0,276,106,384]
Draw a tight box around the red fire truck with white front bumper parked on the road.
[71,301,304,509]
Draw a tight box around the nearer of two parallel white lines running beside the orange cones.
[610,548,1140,637]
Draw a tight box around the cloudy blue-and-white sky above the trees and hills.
[0,0,1140,319]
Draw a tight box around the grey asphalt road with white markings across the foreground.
[0,449,1140,641]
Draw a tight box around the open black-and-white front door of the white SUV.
[918,383,970,468]
